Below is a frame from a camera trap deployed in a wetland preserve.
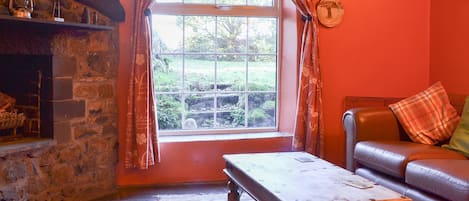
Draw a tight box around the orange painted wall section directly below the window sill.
[118,137,291,185]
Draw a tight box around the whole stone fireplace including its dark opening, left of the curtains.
[0,0,119,200]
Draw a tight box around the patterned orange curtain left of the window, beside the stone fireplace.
[124,0,160,169]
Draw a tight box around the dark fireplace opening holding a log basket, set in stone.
[0,55,53,143]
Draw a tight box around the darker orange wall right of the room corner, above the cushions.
[430,0,469,94]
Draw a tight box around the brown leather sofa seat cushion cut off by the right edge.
[405,159,469,200]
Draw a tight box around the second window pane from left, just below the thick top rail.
[184,16,215,53]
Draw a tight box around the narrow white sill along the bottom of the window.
[159,132,293,143]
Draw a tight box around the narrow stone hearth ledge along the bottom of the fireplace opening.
[0,138,56,157]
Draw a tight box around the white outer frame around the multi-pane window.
[151,0,282,136]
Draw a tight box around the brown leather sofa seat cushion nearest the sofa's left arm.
[354,141,466,178]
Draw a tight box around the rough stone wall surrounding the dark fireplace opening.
[0,0,119,201]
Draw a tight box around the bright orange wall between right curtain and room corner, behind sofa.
[319,0,430,165]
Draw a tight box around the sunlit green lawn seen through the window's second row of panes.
[154,56,276,91]
